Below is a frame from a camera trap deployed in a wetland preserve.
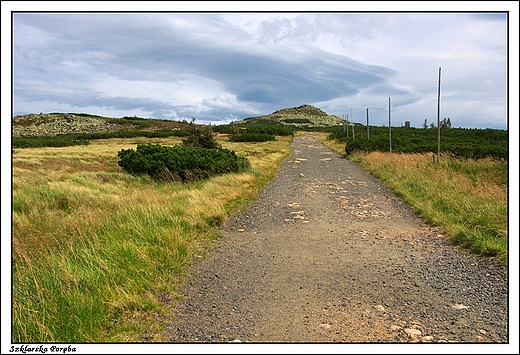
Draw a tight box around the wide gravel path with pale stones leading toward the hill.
[162,134,509,343]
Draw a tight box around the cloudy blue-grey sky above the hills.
[4,2,515,129]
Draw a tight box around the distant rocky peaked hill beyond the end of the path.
[244,105,343,127]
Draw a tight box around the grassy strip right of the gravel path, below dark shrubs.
[320,133,508,264]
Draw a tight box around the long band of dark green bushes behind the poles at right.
[329,125,509,160]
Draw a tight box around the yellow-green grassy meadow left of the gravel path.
[12,137,292,343]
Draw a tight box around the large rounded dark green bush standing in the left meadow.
[117,144,250,182]
